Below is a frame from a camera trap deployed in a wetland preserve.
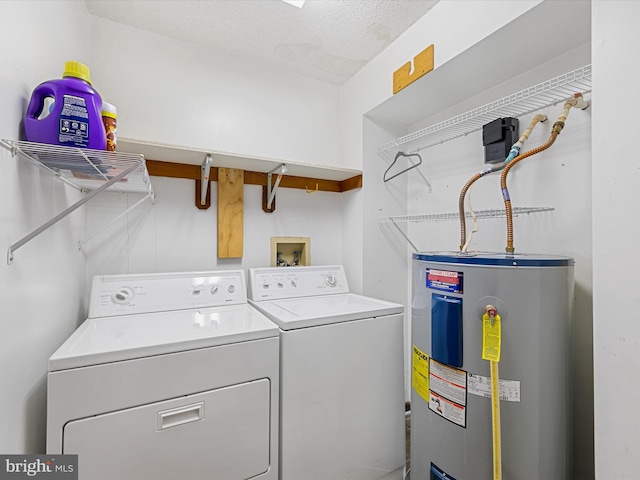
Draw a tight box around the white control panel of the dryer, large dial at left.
[89,270,247,318]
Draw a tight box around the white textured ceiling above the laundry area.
[85,0,438,85]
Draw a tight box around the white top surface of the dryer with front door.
[49,303,279,372]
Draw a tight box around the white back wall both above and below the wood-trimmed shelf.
[82,17,343,278]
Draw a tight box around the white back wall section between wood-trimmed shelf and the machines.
[85,177,342,280]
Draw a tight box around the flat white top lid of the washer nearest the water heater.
[251,293,404,330]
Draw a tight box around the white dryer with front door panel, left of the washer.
[47,270,279,480]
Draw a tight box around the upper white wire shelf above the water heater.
[378,65,591,153]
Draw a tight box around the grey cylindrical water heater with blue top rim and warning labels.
[411,253,573,480]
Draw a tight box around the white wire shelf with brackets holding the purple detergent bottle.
[0,139,155,264]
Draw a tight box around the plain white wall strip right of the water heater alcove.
[592,1,640,480]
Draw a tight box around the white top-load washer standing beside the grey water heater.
[249,266,405,480]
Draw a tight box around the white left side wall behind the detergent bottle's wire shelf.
[0,1,89,454]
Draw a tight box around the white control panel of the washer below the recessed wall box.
[249,265,349,301]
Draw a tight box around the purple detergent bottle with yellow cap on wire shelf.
[24,62,107,150]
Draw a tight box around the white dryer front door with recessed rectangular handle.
[63,379,270,480]
